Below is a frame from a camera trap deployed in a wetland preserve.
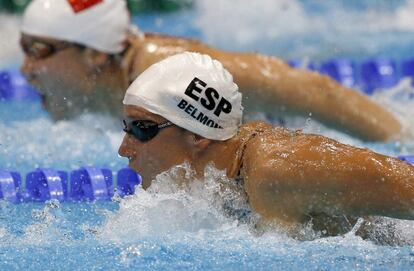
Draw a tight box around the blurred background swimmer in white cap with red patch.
[21,0,402,140]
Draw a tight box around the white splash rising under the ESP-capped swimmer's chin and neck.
[101,164,253,242]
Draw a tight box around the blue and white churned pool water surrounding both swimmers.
[0,0,414,270]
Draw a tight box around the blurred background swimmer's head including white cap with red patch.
[21,0,130,119]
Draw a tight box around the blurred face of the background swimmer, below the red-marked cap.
[20,34,108,118]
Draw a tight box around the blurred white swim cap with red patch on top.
[21,0,130,53]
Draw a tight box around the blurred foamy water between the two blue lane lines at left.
[0,103,127,173]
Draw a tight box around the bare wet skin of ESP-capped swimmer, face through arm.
[119,106,414,234]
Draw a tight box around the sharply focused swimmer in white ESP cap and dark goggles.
[119,53,414,237]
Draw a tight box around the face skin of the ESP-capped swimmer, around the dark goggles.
[118,106,194,189]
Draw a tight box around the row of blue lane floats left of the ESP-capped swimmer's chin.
[0,167,142,203]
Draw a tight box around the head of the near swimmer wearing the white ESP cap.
[119,52,243,187]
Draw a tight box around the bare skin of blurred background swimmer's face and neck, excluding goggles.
[21,35,126,120]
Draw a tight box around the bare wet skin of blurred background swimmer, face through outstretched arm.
[22,34,402,140]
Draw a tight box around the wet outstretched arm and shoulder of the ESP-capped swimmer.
[243,129,414,223]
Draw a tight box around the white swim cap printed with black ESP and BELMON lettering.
[124,52,243,140]
